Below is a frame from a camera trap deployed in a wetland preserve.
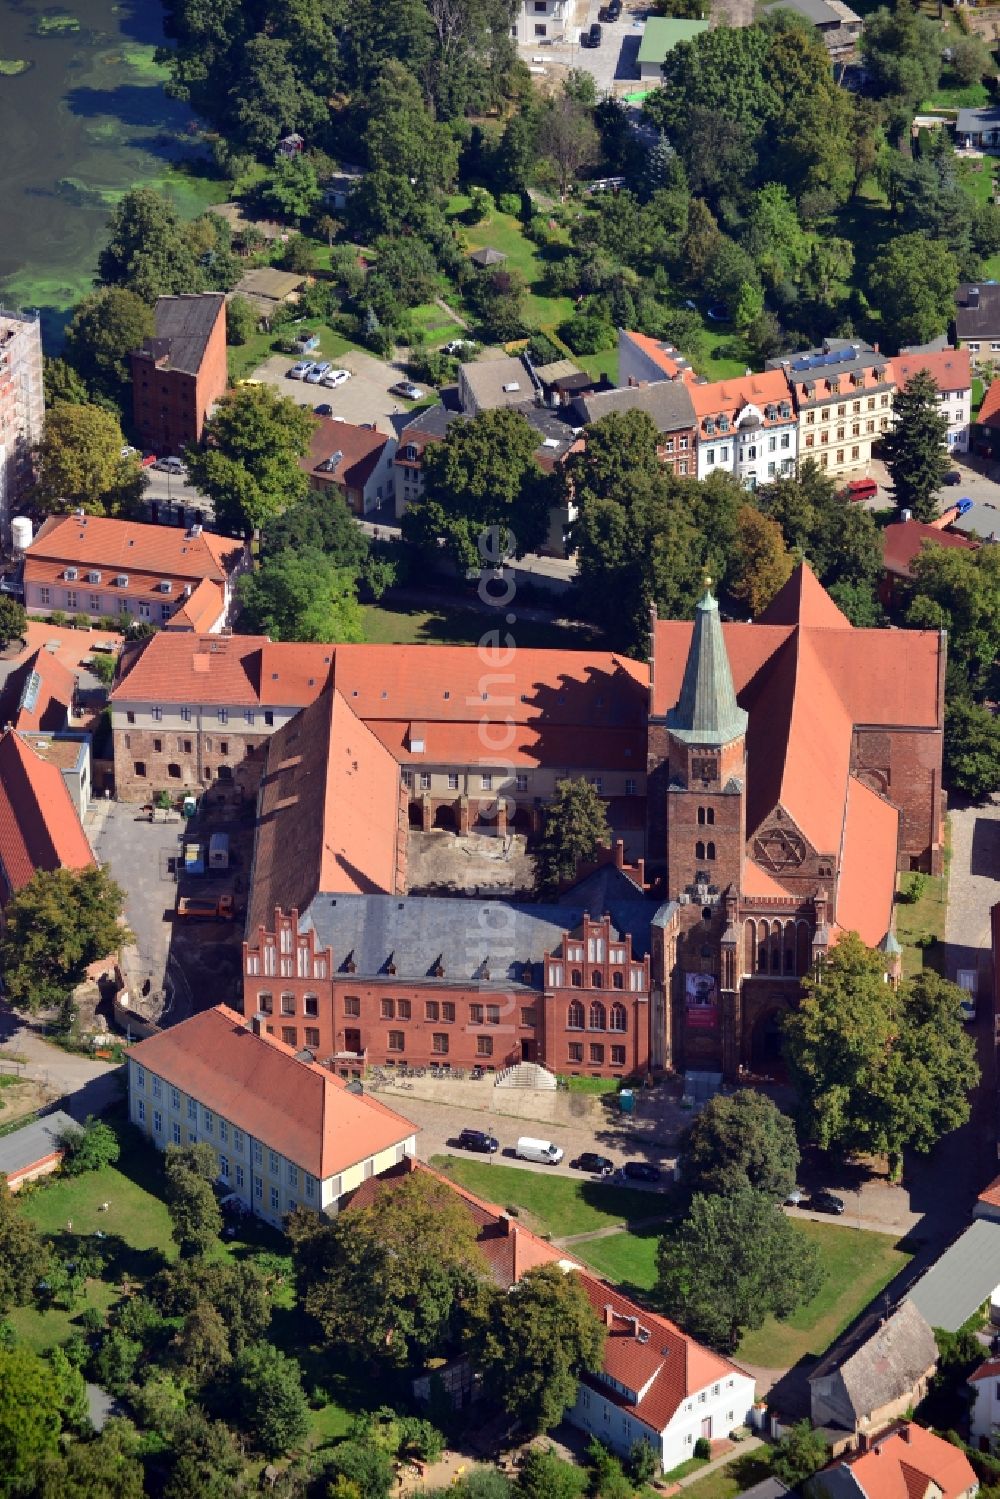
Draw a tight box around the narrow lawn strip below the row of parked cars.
[430,1156,669,1247]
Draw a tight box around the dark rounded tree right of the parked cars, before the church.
[681,1088,799,1202]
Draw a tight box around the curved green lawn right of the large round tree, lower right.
[738,1220,912,1369]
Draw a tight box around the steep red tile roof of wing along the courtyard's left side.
[247,688,399,931]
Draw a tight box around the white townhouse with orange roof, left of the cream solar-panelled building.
[687,370,799,489]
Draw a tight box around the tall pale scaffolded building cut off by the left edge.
[0,307,45,540]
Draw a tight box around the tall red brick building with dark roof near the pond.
[130,291,228,454]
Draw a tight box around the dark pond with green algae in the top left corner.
[0,0,226,343]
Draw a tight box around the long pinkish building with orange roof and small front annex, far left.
[24,511,250,634]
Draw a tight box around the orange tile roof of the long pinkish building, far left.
[24,516,244,588]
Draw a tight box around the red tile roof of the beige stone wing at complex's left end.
[111,630,336,708]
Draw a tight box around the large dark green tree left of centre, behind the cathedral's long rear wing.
[403,406,550,568]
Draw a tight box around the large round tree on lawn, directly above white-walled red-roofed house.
[655,1187,822,1354]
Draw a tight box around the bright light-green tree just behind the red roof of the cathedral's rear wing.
[238,551,364,643]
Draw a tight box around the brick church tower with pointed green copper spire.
[666,586,747,904]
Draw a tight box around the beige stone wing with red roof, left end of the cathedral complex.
[111,630,334,802]
